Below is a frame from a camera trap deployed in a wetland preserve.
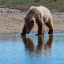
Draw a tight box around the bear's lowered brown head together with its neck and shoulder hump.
[25,6,39,34]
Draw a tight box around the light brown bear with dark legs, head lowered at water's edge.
[21,6,53,36]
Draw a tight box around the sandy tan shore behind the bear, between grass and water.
[0,8,64,34]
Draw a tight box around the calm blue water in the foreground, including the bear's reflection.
[0,33,64,64]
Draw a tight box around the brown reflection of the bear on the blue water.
[21,35,53,53]
